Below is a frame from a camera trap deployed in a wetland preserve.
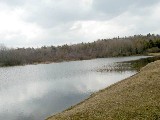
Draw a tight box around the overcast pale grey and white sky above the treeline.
[0,0,160,47]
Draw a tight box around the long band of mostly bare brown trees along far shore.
[0,34,160,66]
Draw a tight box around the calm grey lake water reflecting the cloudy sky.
[0,56,149,120]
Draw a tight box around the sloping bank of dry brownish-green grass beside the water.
[46,60,160,120]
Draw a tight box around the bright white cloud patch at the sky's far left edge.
[0,4,43,46]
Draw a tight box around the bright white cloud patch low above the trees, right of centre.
[70,20,133,41]
